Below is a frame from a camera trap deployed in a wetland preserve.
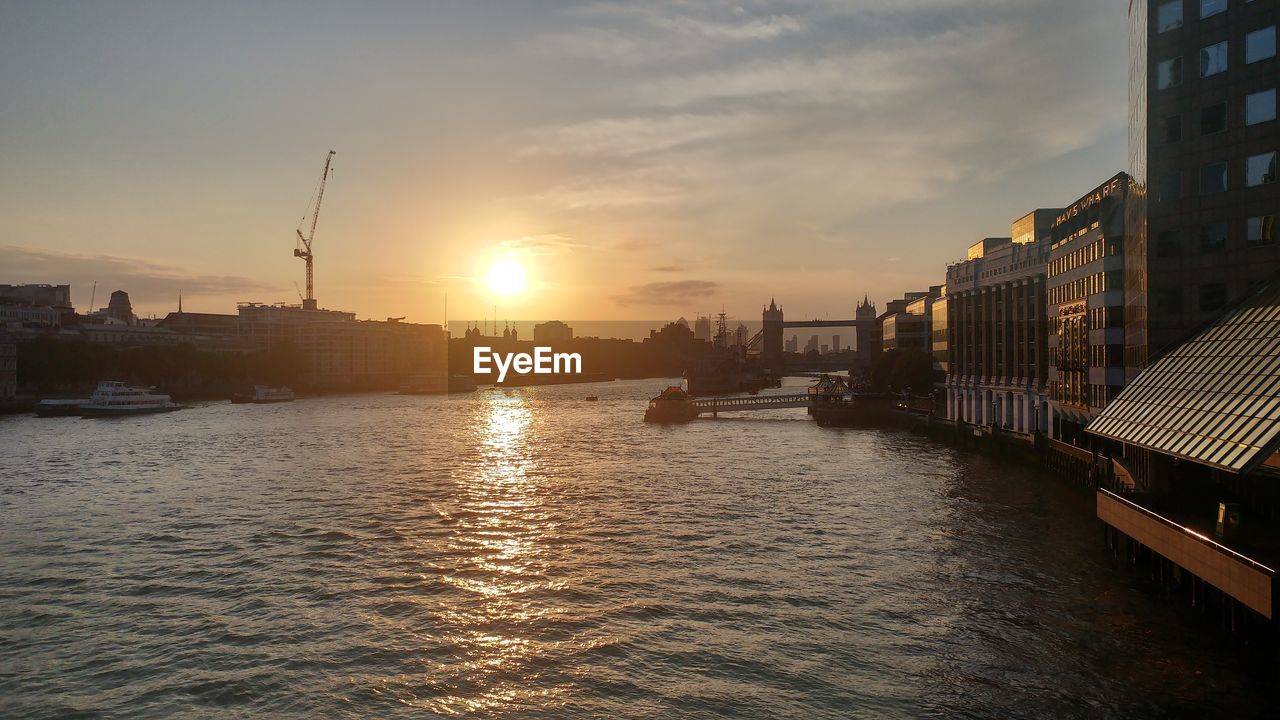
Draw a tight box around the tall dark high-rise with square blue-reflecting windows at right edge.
[1125,0,1280,368]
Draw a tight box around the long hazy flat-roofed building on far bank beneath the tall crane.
[238,302,448,389]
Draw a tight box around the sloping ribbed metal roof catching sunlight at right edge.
[1087,282,1280,473]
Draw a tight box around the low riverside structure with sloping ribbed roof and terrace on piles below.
[1088,279,1280,629]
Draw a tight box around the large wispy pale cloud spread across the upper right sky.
[516,0,1125,229]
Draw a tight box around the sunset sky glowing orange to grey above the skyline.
[0,0,1128,322]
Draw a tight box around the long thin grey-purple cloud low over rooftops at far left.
[0,245,280,305]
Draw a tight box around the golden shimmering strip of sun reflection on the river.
[415,392,568,715]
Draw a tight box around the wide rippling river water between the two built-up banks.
[0,380,1277,717]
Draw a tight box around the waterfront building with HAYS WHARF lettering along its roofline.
[1047,173,1130,445]
